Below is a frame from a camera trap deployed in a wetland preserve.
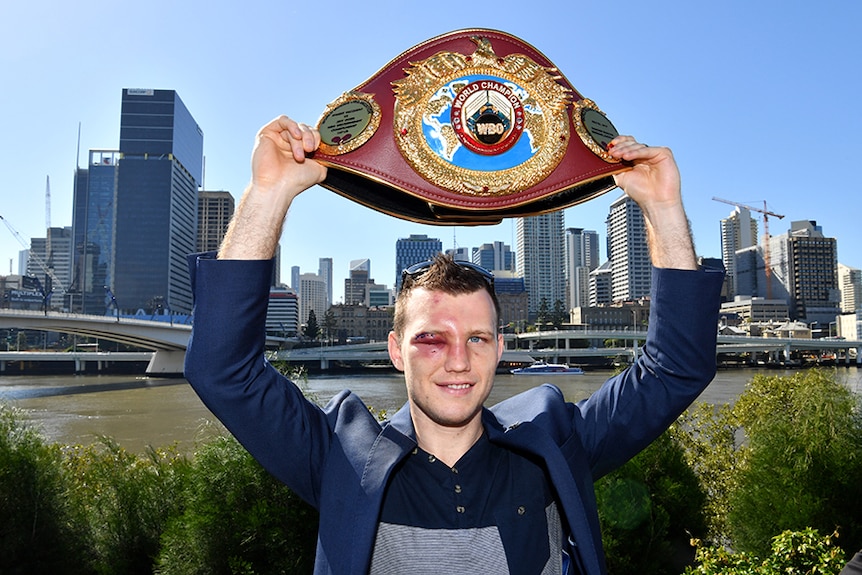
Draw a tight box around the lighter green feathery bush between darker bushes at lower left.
[65,438,190,574]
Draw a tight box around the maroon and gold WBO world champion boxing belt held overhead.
[314,29,628,224]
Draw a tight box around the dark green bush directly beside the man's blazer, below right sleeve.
[596,432,706,575]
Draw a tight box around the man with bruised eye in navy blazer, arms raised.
[186,116,723,574]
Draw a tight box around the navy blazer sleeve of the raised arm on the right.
[573,268,724,479]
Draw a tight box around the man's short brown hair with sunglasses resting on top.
[392,254,500,337]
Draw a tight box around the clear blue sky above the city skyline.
[0,0,862,299]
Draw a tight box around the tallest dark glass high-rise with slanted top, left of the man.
[112,89,203,313]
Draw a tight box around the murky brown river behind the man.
[0,366,862,453]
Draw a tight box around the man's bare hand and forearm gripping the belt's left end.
[218,116,326,259]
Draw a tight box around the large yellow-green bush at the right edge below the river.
[728,370,862,553]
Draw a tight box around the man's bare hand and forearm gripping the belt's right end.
[608,136,697,269]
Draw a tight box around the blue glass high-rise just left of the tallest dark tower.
[67,150,120,315]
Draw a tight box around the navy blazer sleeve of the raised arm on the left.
[185,254,331,506]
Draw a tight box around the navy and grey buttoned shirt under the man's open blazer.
[370,434,565,575]
